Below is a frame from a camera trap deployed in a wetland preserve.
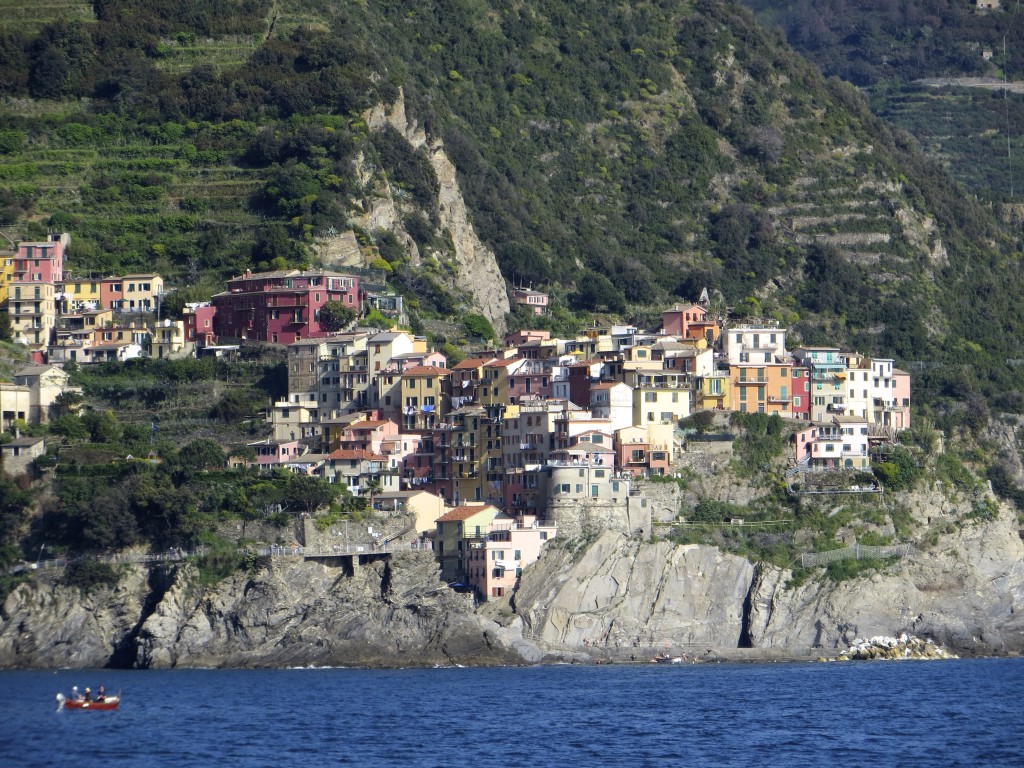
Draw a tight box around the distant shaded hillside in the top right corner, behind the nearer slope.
[742,0,1024,204]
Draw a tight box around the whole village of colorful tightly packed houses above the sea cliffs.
[0,234,910,599]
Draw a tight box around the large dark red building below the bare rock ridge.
[212,269,359,344]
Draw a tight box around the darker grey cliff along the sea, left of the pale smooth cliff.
[0,553,542,668]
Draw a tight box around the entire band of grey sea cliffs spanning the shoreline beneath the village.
[0,496,1024,668]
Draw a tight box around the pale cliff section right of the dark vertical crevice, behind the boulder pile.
[750,507,1024,654]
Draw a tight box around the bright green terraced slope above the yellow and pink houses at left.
[0,111,261,282]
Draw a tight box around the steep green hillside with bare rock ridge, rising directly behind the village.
[0,0,1024,397]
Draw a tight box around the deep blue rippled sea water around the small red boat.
[0,659,1024,768]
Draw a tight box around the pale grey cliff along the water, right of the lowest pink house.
[514,501,1024,654]
